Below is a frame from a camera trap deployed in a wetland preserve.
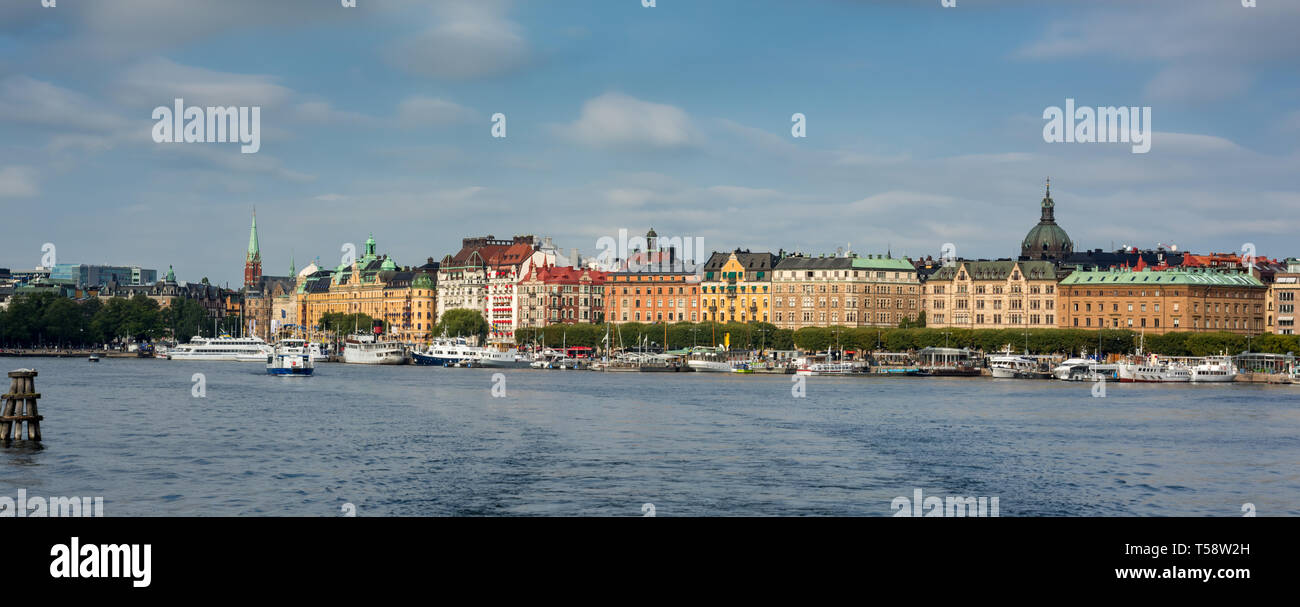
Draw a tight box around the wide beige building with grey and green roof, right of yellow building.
[771,252,923,329]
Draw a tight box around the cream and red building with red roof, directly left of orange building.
[519,265,606,328]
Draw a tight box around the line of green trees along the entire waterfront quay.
[0,294,1300,356]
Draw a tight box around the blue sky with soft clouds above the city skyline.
[0,0,1300,286]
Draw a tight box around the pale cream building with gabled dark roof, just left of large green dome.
[924,260,1058,329]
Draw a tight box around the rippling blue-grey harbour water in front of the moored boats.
[0,359,1300,516]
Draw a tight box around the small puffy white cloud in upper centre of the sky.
[559,92,699,148]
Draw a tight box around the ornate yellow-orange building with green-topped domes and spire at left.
[295,234,438,343]
